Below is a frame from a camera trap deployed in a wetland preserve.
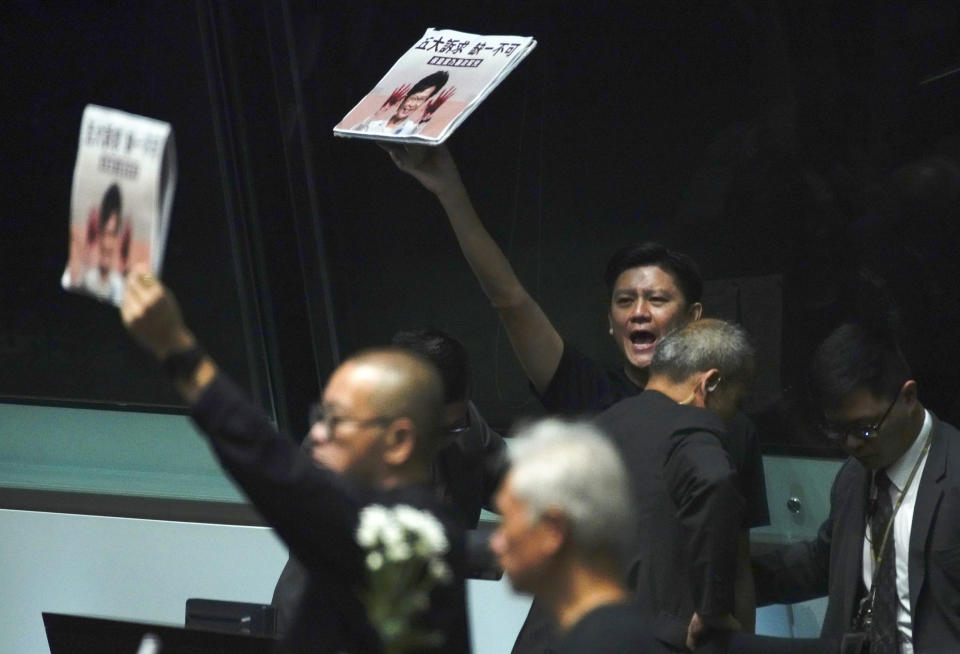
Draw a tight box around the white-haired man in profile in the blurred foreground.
[490,419,668,654]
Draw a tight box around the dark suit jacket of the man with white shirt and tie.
[753,418,960,654]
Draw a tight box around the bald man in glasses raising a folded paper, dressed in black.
[121,273,469,653]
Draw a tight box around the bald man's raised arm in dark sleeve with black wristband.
[121,272,360,576]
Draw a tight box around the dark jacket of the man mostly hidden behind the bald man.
[271,402,508,634]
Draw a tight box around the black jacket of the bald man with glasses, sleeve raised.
[193,375,470,654]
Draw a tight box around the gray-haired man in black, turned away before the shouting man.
[596,320,763,651]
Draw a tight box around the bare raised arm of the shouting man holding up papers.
[383,144,563,393]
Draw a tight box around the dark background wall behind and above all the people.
[0,0,960,452]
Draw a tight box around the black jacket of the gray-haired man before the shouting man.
[596,390,744,649]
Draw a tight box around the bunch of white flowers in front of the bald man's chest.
[356,504,453,654]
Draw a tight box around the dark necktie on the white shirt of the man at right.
[869,472,900,654]
